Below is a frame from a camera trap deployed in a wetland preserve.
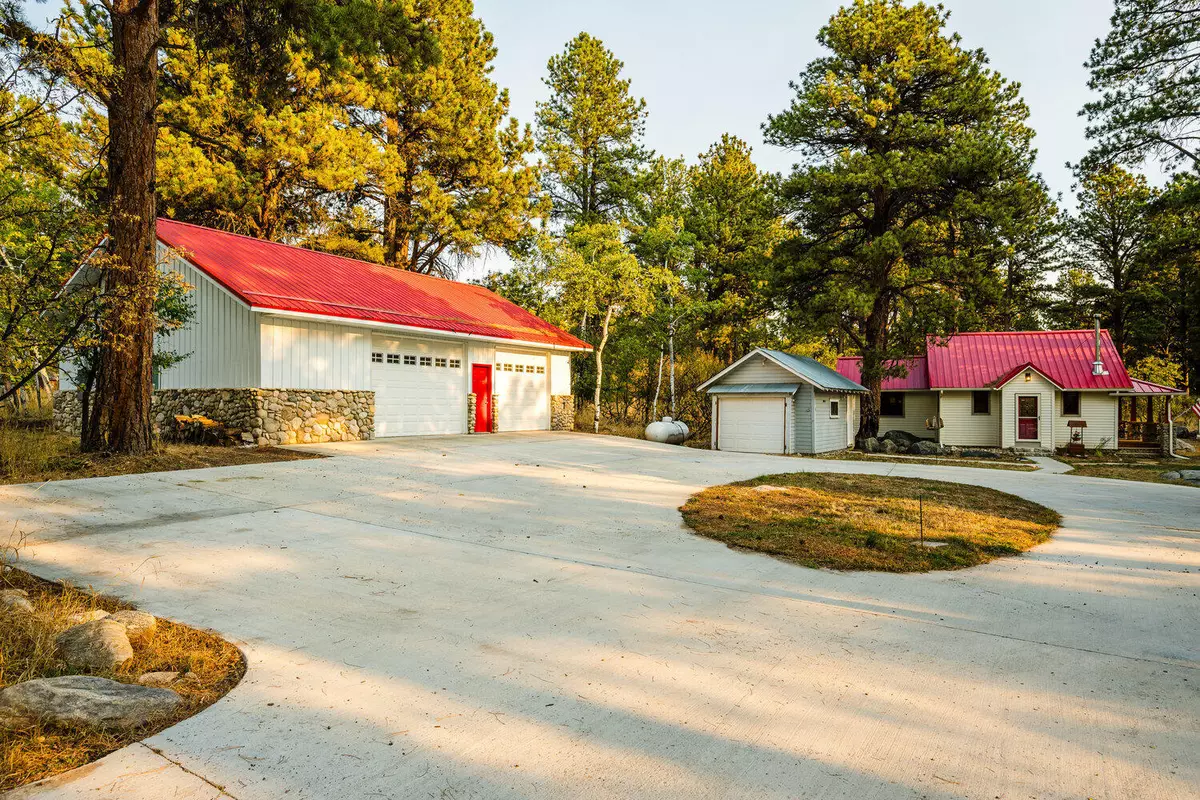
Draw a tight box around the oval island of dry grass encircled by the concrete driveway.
[680,473,1062,572]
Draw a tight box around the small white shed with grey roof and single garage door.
[700,348,866,453]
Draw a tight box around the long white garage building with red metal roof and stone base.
[62,219,592,444]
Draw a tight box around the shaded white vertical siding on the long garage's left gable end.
[155,243,258,389]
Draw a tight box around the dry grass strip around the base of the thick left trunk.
[0,425,322,485]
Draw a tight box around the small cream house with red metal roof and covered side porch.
[836,326,1183,450]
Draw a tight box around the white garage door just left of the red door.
[371,336,467,437]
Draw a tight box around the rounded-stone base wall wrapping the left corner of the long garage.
[54,389,374,445]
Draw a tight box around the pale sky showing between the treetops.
[14,0,1128,277]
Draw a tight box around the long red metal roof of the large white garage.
[158,219,592,350]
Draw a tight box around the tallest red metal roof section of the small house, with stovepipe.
[926,330,1133,390]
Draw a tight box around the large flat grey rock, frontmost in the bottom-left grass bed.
[0,675,182,729]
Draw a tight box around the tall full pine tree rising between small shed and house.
[766,0,1033,440]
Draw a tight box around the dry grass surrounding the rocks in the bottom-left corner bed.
[0,566,246,792]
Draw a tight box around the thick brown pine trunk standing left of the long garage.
[82,0,158,453]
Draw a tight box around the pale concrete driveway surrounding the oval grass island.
[0,434,1200,800]
